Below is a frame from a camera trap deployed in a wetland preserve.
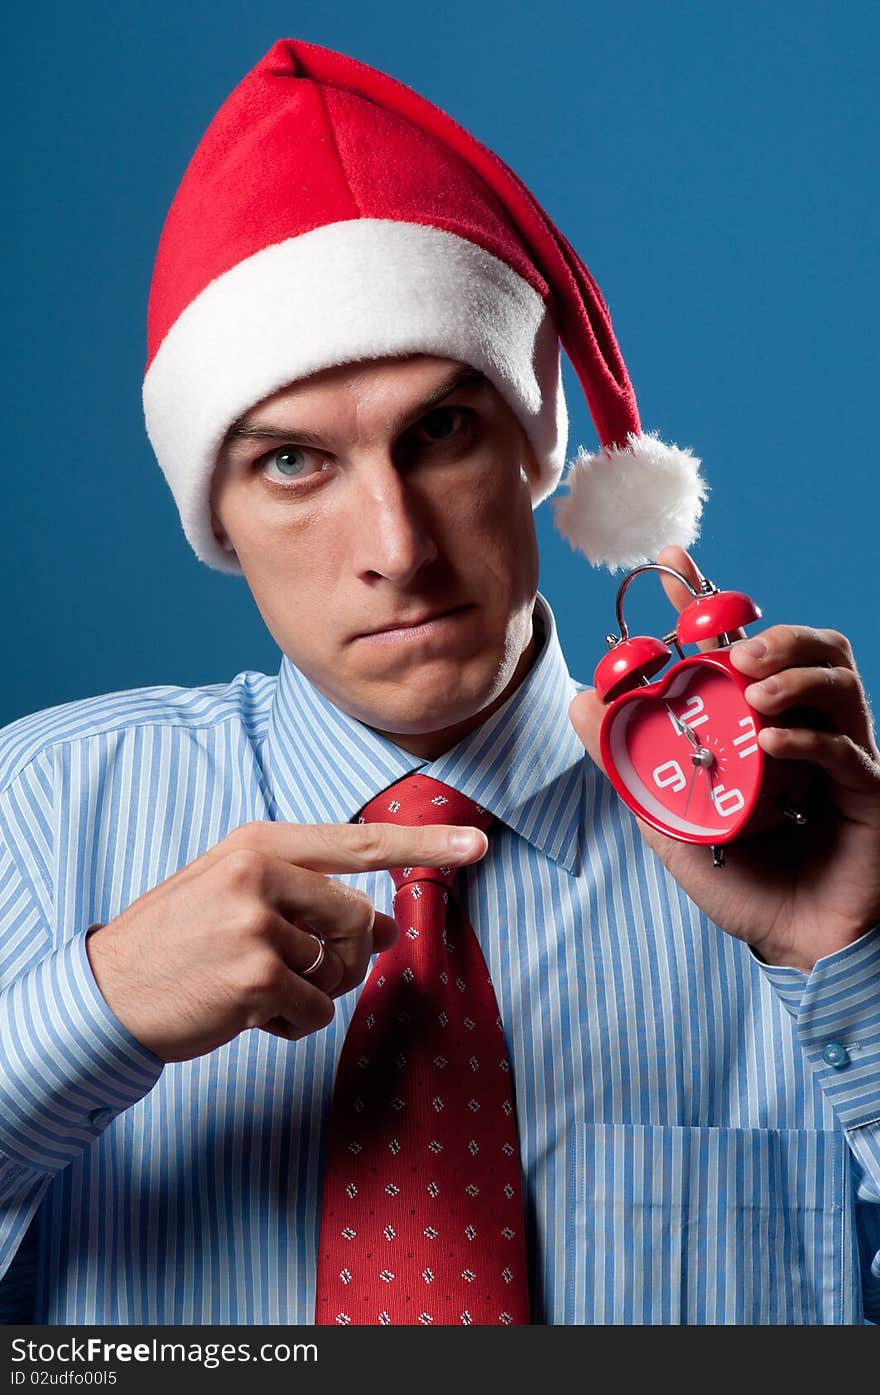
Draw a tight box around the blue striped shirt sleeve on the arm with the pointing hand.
[0,771,163,1276]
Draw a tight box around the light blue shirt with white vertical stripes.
[0,597,880,1324]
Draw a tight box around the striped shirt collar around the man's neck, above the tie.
[264,591,591,872]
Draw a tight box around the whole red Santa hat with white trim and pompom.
[144,39,707,573]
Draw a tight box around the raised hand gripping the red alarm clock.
[569,547,880,971]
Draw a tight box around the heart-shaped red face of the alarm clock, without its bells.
[600,650,764,843]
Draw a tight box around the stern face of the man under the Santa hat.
[212,354,538,759]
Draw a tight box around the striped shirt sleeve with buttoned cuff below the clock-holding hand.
[752,926,880,1321]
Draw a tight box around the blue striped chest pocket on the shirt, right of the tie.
[565,1124,863,1325]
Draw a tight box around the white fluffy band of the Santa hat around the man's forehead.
[144,219,568,573]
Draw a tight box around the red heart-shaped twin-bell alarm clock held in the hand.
[594,562,816,866]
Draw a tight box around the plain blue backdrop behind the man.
[0,0,880,723]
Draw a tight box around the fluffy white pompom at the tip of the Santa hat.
[551,432,708,572]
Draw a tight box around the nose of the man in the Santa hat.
[351,458,439,586]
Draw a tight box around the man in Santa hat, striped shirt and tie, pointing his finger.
[0,29,880,1325]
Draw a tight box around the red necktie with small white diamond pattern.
[315,774,529,1327]
